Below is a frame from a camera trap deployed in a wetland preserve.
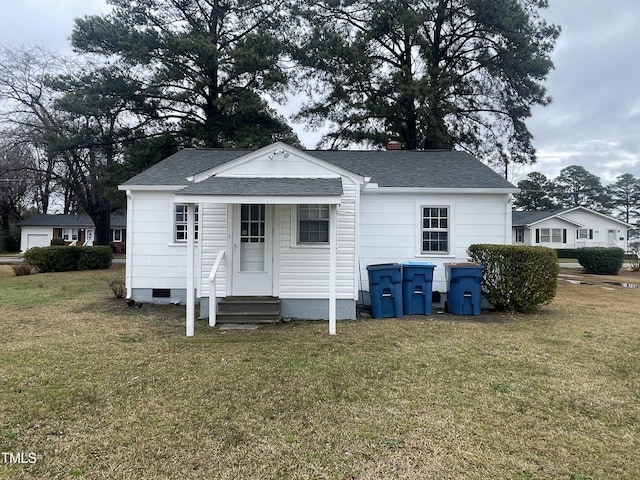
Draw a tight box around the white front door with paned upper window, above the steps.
[232,204,273,295]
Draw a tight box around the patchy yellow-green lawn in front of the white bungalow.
[0,266,640,480]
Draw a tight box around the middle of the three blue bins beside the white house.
[402,261,435,315]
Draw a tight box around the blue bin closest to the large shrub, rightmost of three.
[445,263,484,315]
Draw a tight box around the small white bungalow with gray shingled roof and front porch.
[119,143,518,335]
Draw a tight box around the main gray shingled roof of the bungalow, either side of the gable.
[123,149,515,189]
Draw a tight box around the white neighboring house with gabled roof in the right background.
[512,207,633,251]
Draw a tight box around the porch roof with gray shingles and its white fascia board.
[175,176,342,204]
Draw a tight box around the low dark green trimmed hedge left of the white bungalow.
[24,246,113,273]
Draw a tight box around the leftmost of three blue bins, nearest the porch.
[367,263,402,318]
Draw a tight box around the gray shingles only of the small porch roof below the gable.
[180,177,342,196]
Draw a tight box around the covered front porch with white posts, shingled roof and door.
[174,176,348,336]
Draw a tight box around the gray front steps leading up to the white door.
[217,297,281,323]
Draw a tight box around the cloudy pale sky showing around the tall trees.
[0,0,640,184]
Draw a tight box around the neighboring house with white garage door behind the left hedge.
[18,215,126,253]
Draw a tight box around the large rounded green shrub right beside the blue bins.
[468,244,559,312]
